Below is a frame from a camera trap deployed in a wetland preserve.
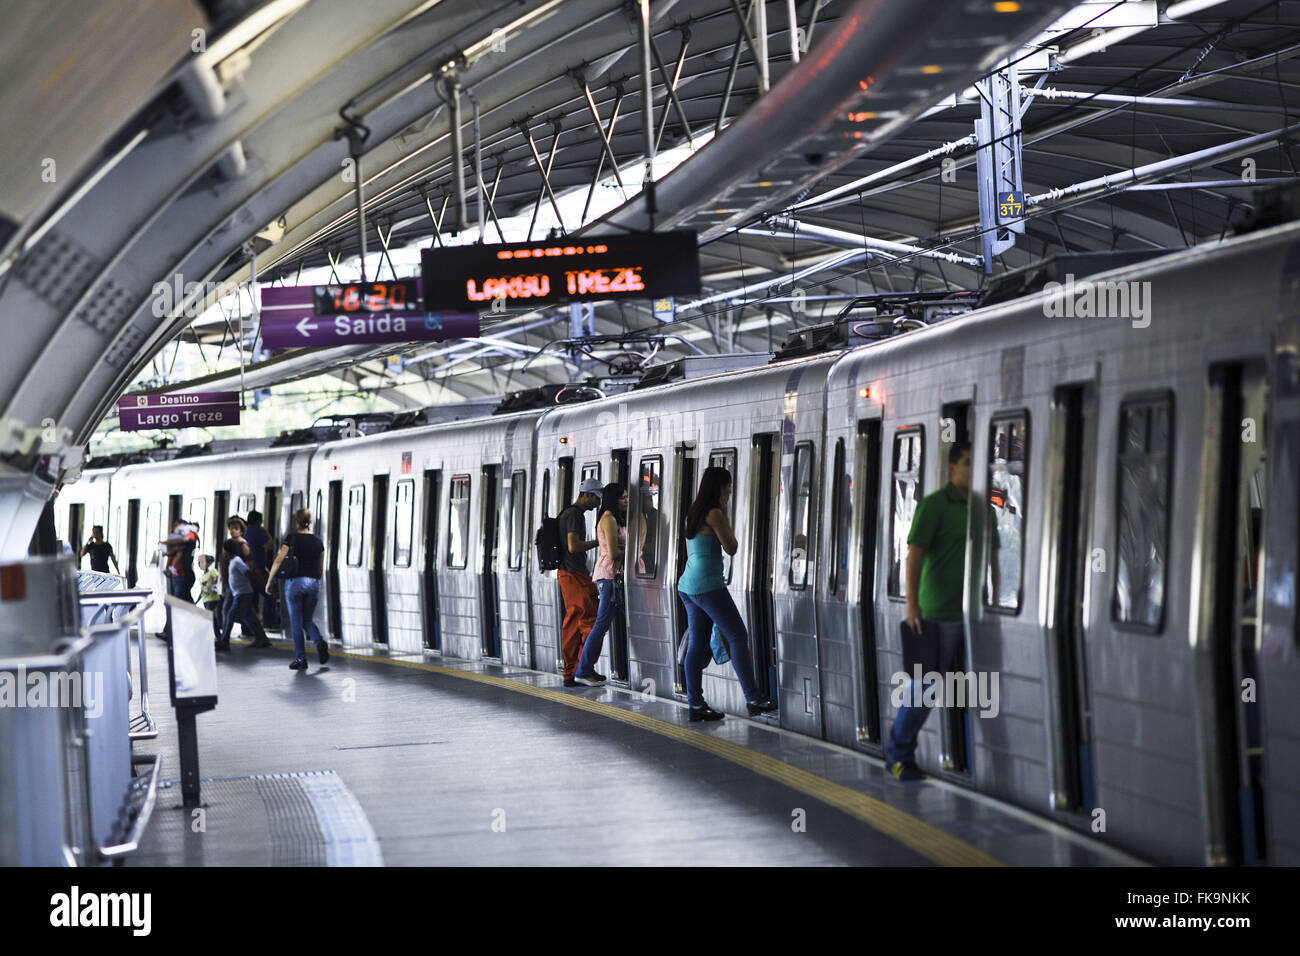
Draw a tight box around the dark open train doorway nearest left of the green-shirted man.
[852,419,883,747]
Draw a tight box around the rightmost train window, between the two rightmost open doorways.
[1112,397,1173,632]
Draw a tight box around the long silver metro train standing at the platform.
[56,214,1300,865]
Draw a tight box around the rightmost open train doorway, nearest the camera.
[1197,363,1268,865]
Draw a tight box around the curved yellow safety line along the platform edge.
[258,650,1006,866]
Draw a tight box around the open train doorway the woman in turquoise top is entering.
[748,433,781,702]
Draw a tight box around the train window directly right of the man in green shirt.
[984,411,1030,614]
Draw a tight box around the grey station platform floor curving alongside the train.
[127,635,1140,866]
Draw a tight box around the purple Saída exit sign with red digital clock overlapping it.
[261,278,478,349]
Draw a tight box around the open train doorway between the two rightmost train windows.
[1044,385,1097,813]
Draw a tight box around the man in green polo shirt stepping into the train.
[885,442,971,780]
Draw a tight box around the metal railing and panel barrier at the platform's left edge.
[0,558,160,866]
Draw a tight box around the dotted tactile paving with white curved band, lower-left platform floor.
[157,770,384,866]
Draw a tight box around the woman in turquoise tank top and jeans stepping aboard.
[677,466,776,721]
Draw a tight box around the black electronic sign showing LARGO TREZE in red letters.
[421,230,699,312]
